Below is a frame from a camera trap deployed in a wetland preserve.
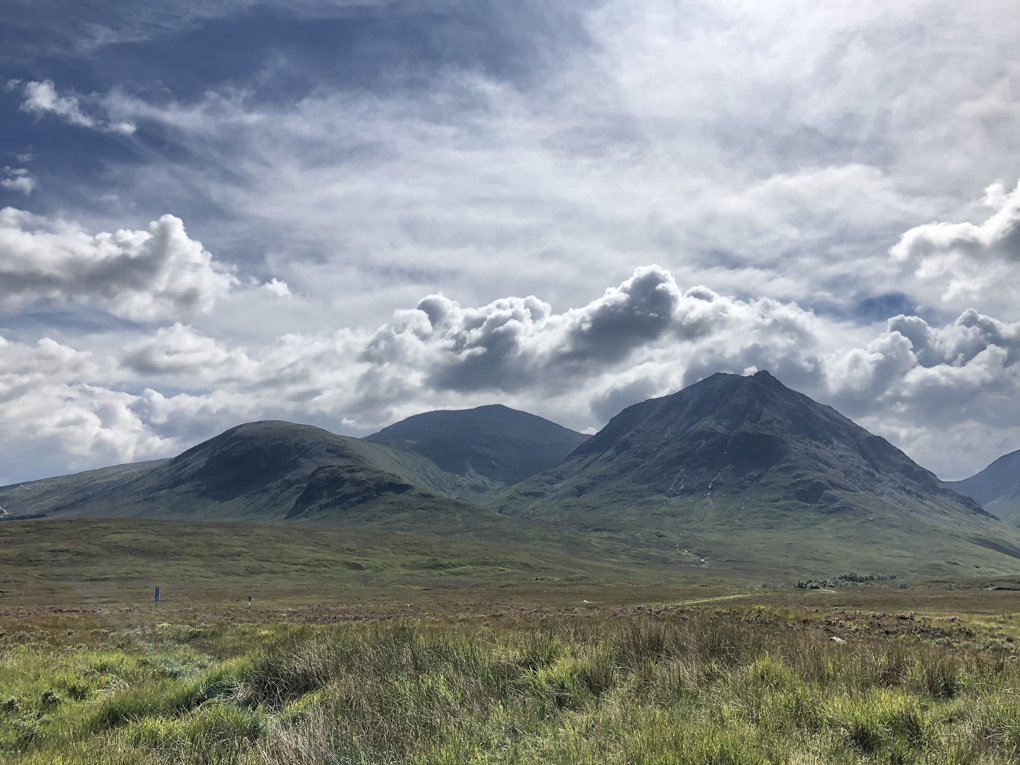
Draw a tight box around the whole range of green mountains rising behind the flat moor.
[0,371,1020,578]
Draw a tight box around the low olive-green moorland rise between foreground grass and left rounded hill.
[0,519,714,608]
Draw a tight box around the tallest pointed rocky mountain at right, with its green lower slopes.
[483,371,1020,575]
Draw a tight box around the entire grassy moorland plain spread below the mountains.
[0,520,1020,765]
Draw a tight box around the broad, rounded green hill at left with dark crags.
[0,421,501,529]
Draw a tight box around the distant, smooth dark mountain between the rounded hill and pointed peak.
[367,405,590,497]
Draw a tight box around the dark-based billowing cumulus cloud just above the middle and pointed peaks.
[362,266,817,401]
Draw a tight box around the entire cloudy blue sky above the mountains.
[0,0,1020,483]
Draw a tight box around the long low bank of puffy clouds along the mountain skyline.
[0,266,1020,477]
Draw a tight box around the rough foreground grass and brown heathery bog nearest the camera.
[0,588,1020,765]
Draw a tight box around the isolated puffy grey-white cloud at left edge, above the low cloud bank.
[0,207,237,321]
